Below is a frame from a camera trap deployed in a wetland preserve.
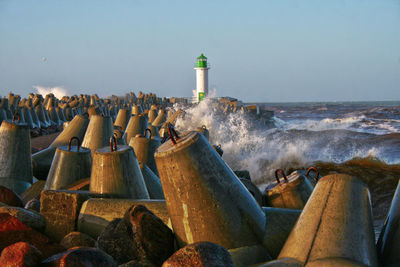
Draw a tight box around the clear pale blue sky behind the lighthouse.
[0,0,400,102]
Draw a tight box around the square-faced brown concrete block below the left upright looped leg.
[40,190,89,241]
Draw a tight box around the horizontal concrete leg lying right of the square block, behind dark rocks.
[78,198,169,238]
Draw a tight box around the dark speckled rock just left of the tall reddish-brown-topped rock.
[97,219,138,264]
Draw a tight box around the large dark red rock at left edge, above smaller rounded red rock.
[0,213,65,258]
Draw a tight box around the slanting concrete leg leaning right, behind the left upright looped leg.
[32,115,89,180]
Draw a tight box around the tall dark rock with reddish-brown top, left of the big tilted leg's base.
[125,205,175,266]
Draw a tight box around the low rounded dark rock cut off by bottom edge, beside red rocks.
[42,247,118,267]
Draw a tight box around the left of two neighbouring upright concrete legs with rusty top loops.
[44,137,92,190]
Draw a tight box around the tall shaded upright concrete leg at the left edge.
[0,120,32,193]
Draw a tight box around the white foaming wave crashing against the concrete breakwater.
[176,99,400,185]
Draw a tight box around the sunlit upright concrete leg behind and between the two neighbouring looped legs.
[82,115,114,153]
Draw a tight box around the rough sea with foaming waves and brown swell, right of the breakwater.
[175,99,400,232]
